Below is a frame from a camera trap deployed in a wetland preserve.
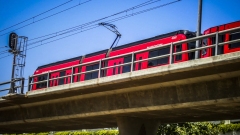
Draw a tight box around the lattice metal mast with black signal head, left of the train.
[0,32,28,99]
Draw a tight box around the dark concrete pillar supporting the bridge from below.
[117,117,159,135]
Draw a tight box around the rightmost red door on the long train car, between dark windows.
[134,52,148,70]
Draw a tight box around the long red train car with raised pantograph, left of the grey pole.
[31,30,196,90]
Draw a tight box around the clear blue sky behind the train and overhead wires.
[0,0,240,95]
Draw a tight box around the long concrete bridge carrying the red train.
[0,52,240,135]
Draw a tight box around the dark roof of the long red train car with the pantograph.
[37,30,194,70]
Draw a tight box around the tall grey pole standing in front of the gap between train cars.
[195,0,202,59]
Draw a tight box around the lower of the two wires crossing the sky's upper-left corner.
[0,0,92,37]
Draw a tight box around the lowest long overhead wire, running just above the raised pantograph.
[0,0,180,59]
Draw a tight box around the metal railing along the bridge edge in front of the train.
[29,27,240,89]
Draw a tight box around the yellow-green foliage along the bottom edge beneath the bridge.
[4,122,240,135]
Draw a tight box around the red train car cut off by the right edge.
[201,21,240,58]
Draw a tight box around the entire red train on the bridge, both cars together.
[31,21,240,90]
